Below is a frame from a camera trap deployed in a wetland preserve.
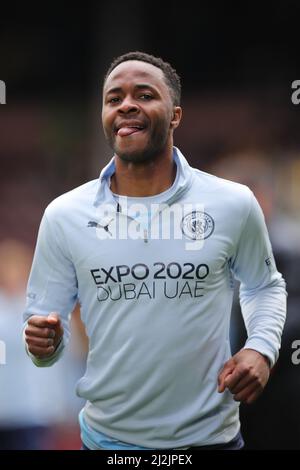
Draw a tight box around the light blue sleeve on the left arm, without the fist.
[23,206,77,367]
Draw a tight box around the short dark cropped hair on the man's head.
[104,51,181,106]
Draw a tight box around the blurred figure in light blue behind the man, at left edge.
[0,239,86,450]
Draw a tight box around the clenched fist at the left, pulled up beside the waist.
[25,312,64,359]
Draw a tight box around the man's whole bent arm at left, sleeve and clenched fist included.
[23,205,77,367]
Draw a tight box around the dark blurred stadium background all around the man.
[0,0,300,449]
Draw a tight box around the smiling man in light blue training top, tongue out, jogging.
[25,52,286,449]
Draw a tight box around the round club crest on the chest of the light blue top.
[180,211,215,240]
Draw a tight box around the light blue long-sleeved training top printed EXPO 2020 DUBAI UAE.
[24,147,286,449]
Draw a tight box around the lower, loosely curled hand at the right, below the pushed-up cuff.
[218,349,270,404]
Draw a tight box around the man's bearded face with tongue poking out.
[102,60,181,163]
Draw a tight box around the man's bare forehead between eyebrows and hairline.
[103,60,168,93]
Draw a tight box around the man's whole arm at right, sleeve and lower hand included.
[219,189,286,403]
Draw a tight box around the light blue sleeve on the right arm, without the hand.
[231,193,287,366]
